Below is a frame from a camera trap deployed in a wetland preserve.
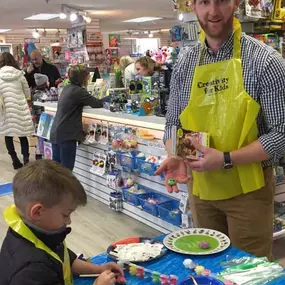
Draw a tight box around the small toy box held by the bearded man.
[172,126,210,160]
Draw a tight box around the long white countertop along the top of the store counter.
[34,102,165,131]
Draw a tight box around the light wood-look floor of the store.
[0,138,285,262]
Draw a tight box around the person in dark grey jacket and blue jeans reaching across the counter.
[50,65,108,170]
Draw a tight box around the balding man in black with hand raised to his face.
[26,50,61,89]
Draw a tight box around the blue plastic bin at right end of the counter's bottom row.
[157,200,182,227]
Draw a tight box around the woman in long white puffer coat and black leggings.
[0,52,34,169]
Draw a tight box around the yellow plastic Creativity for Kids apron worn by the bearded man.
[180,19,264,200]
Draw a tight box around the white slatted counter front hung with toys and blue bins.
[36,103,285,236]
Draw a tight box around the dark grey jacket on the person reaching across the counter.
[50,84,108,144]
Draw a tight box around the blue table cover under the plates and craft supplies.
[74,236,285,285]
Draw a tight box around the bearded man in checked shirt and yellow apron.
[156,0,285,259]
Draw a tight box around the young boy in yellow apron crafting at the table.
[0,160,123,285]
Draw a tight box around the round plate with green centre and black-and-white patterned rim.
[163,228,231,255]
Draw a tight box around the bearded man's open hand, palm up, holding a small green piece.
[154,156,191,193]
